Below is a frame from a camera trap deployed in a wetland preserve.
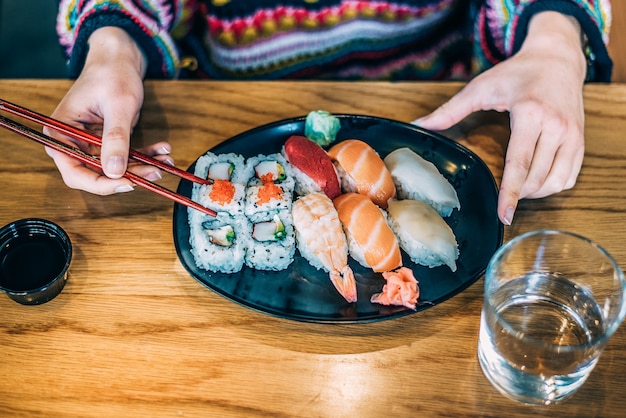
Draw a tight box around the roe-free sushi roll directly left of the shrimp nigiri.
[245,211,296,271]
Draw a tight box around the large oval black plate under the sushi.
[173,115,503,323]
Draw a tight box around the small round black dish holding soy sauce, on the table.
[0,218,72,305]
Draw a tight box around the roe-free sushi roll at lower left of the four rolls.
[189,212,251,273]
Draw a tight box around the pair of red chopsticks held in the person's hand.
[0,99,217,216]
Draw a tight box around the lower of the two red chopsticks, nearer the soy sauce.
[0,116,217,217]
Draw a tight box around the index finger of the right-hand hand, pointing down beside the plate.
[498,117,540,225]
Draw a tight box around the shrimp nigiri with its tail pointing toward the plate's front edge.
[291,193,357,302]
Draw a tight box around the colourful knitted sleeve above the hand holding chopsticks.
[57,0,195,78]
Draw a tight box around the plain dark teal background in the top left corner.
[0,0,67,78]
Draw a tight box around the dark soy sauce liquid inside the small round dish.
[0,234,66,291]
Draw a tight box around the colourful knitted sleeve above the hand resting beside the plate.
[473,0,613,82]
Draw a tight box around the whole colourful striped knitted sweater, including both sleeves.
[57,0,612,81]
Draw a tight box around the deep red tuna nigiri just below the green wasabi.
[282,135,341,200]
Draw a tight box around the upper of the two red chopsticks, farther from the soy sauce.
[0,99,211,184]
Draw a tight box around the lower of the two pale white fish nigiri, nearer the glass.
[387,199,459,271]
